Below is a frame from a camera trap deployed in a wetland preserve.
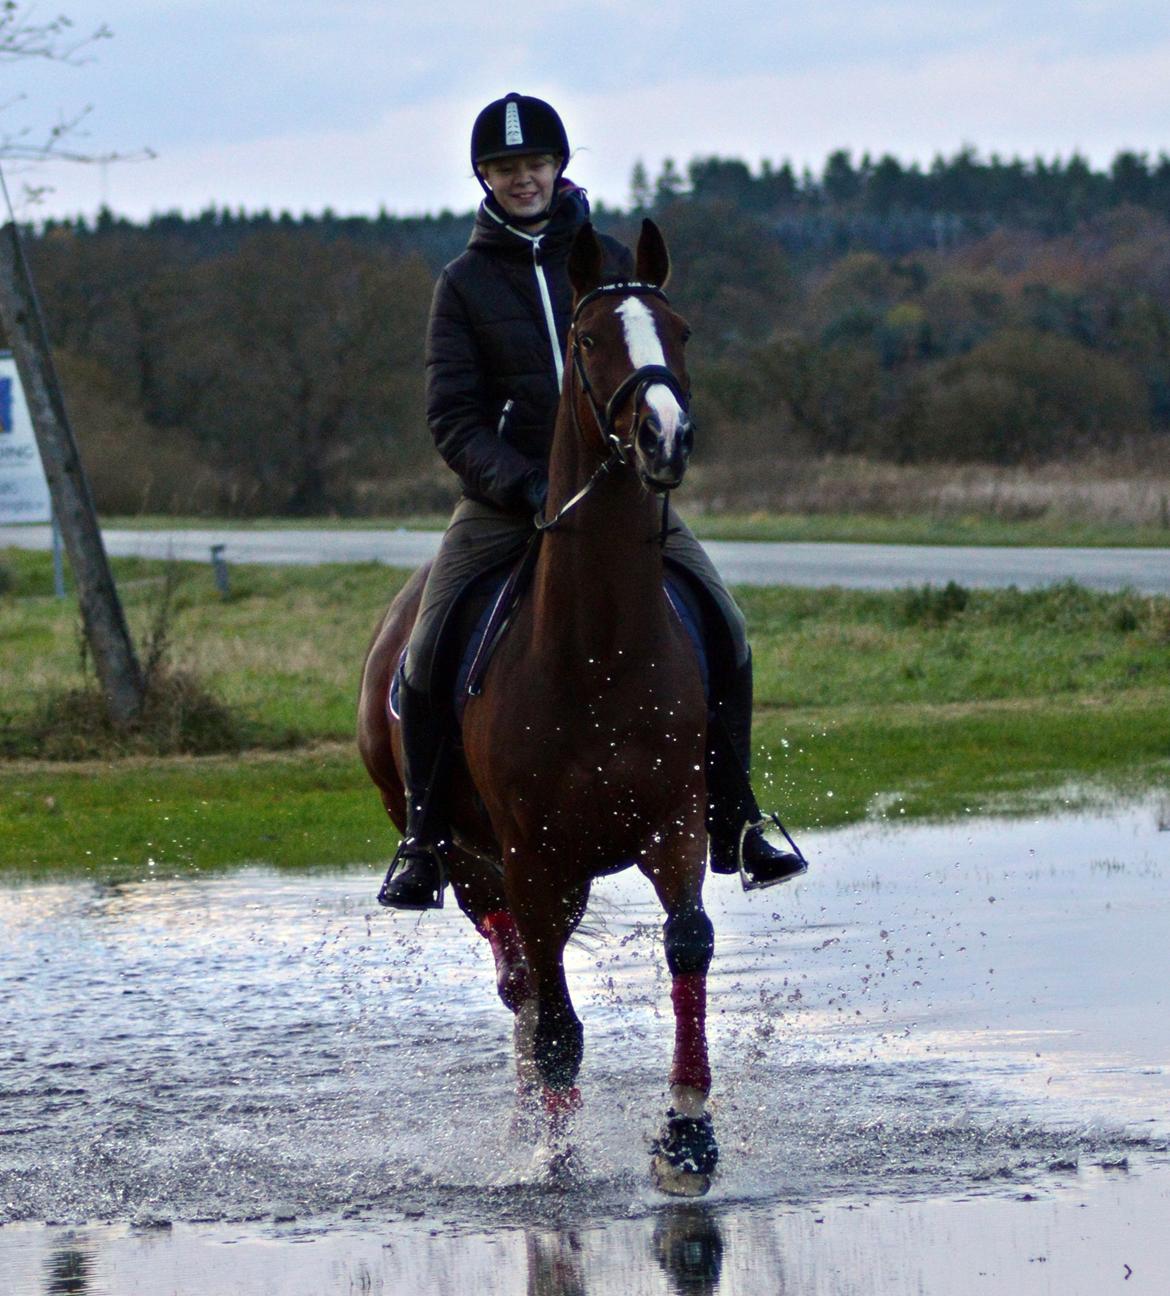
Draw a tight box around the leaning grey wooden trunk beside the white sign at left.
[0,222,145,728]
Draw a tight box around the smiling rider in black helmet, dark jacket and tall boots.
[378,93,805,908]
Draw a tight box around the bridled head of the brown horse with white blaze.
[569,220,694,491]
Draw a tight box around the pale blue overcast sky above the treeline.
[0,0,1170,218]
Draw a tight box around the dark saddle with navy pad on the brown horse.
[386,534,722,730]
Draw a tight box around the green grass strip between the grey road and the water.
[0,551,1170,877]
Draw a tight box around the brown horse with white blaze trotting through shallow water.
[359,220,718,1196]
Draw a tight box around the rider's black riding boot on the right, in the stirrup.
[707,657,809,889]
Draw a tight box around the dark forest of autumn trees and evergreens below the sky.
[9,149,1170,515]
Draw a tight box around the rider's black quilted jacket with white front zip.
[426,181,632,512]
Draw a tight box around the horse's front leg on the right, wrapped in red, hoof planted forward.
[641,833,719,1196]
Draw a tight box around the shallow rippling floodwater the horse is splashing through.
[0,798,1170,1296]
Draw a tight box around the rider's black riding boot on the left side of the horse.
[378,679,450,908]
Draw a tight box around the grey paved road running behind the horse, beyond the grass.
[0,526,1170,594]
